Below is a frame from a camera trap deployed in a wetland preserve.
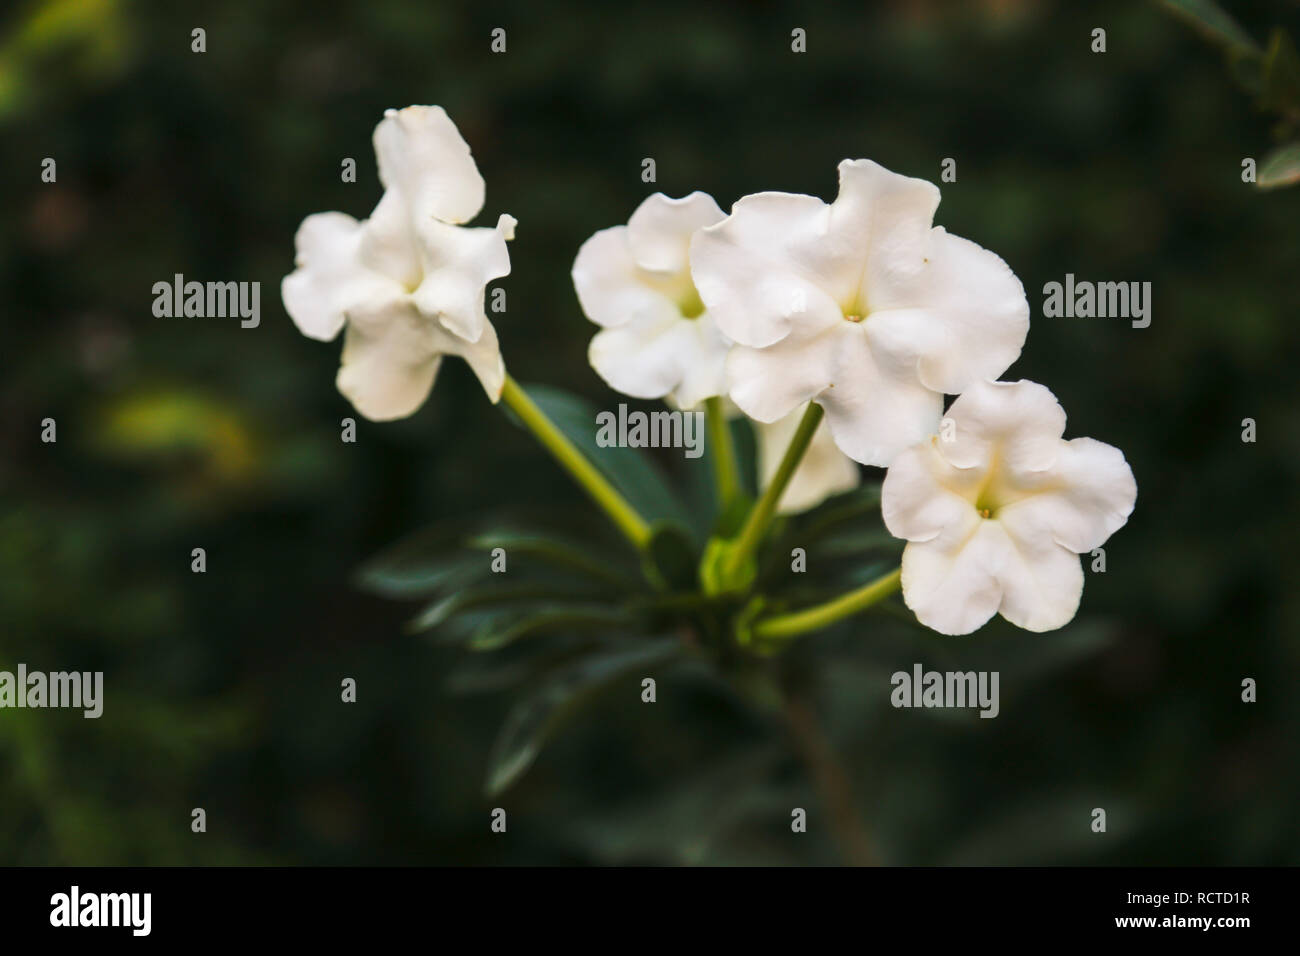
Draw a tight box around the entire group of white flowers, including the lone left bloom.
[282,107,1136,633]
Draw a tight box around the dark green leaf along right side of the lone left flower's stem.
[514,385,692,528]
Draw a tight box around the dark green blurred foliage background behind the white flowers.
[0,0,1300,864]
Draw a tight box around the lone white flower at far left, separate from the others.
[281,107,515,421]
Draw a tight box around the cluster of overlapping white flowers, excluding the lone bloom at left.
[573,160,1138,633]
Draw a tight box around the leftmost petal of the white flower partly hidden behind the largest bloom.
[573,226,689,329]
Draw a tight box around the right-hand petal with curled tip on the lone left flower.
[413,219,510,342]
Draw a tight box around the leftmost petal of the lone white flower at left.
[280,212,393,342]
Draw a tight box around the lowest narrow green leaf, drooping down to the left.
[485,639,681,796]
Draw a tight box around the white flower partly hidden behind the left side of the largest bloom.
[573,193,731,408]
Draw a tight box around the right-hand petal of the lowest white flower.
[997,438,1138,554]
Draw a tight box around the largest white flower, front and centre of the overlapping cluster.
[690,160,1030,466]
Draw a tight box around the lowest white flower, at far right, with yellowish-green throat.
[880,381,1138,633]
